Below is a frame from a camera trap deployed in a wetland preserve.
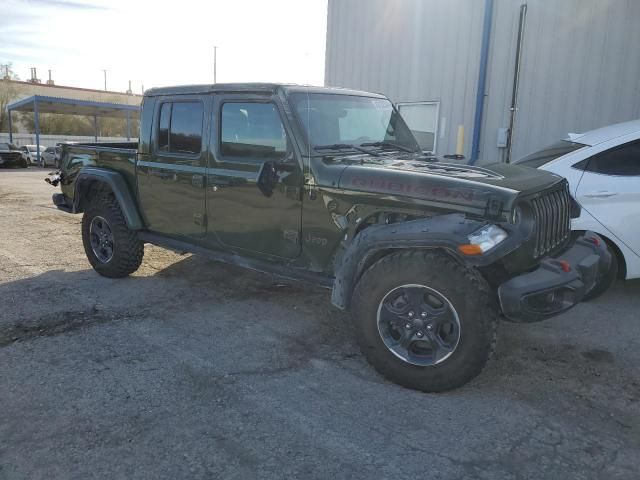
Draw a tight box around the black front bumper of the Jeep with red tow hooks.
[498,232,611,322]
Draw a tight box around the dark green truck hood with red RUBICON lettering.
[331,154,562,218]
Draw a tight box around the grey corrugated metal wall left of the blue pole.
[325,0,483,158]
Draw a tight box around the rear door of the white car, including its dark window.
[576,140,640,255]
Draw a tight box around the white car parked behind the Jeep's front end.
[514,120,640,298]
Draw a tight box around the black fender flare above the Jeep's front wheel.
[331,214,513,310]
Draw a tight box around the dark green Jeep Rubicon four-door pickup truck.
[50,84,611,392]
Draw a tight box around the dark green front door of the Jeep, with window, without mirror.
[207,94,302,258]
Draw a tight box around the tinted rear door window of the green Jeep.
[158,102,204,153]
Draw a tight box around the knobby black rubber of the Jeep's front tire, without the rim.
[352,250,498,392]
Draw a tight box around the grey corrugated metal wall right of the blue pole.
[481,0,640,160]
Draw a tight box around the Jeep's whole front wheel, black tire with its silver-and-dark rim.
[353,251,498,392]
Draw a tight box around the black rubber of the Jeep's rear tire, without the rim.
[82,193,144,278]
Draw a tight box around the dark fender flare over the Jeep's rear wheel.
[73,167,143,230]
